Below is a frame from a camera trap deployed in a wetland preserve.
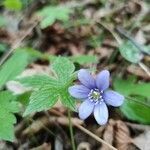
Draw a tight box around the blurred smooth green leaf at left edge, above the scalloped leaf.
[0,50,29,87]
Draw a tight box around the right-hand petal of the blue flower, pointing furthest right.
[103,90,124,107]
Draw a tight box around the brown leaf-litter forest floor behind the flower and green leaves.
[0,0,150,150]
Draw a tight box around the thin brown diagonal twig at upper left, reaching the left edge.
[0,21,38,66]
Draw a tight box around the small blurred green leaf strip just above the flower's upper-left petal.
[70,55,98,65]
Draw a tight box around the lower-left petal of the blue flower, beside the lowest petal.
[79,99,94,120]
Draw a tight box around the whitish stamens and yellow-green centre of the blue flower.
[88,89,103,103]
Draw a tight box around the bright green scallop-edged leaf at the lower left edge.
[0,91,19,141]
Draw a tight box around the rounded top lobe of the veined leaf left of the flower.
[52,57,75,84]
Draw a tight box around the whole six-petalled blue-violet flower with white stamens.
[69,69,124,125]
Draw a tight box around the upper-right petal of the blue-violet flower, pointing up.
[96,70,110,91]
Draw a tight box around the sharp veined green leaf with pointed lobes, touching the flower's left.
[18,57,75,115]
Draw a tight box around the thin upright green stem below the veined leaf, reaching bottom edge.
[68,109,76,150]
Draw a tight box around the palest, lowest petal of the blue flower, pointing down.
[94,102,108,125]
